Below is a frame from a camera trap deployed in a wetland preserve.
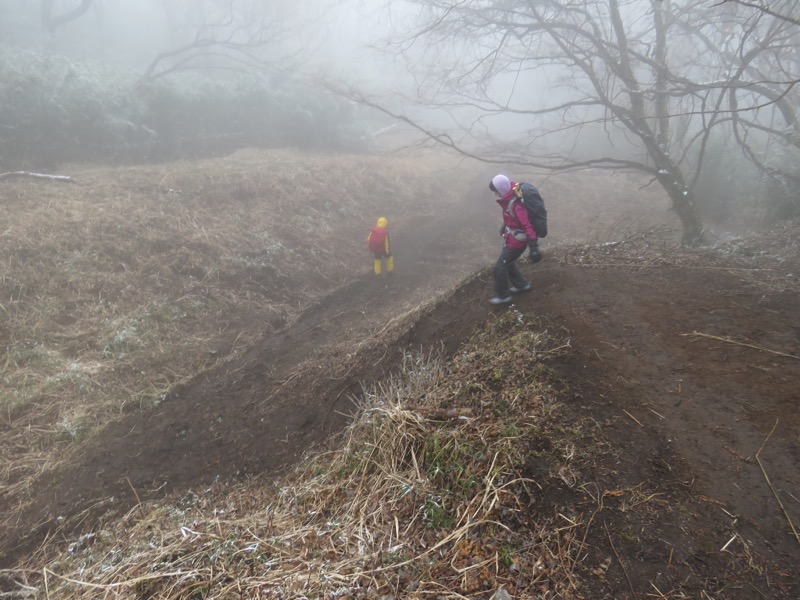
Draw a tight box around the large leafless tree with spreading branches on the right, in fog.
[368,0,798,244]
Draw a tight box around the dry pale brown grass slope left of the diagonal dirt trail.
[0,150,472,528]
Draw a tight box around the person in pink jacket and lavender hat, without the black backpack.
[489,174,542,305]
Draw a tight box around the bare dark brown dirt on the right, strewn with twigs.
[520,264,800,573]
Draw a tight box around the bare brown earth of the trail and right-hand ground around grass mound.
[2,156,800,598]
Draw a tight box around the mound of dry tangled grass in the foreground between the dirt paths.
[6,312,584,598]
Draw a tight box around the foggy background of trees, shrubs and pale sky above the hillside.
[0,0,800,239]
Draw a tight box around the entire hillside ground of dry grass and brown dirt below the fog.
[0,150,800,599]
